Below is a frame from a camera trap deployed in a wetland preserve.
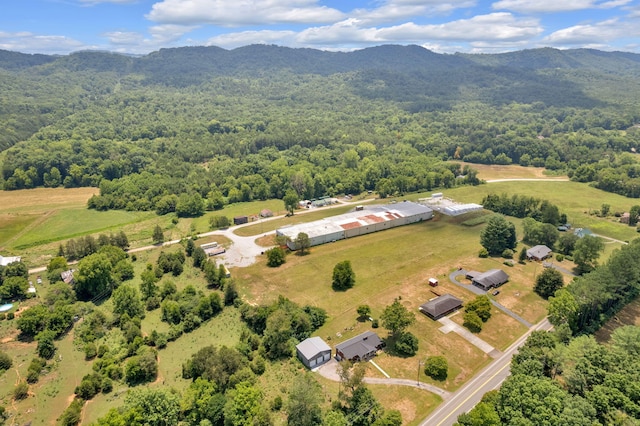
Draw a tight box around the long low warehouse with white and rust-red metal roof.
[276,201,433,250]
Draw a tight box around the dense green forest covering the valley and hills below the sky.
[0,46,640,213]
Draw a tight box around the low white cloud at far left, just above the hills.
[0,32,85,55]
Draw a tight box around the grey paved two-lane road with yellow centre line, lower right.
[420,318,552,426]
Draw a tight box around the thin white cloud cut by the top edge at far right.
[491,0,631,13]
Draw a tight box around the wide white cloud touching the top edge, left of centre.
[146,0,344,27]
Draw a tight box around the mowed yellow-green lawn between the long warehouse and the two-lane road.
[236,217,545,390]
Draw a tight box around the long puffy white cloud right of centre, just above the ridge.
[296,13,543,45]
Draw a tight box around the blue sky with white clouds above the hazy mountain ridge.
[0,0,640,54]
